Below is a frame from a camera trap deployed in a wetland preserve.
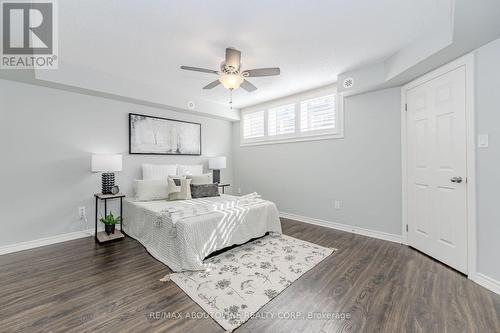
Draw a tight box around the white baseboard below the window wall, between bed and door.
[280,212,403,243]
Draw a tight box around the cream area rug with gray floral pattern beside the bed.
[170,235,335,331]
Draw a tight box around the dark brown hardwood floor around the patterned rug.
[0,220,500,333]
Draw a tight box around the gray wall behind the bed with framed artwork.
[0,80,232,246]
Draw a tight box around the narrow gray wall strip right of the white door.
[475,39,500,281]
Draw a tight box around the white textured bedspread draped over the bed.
[123,195,281,272]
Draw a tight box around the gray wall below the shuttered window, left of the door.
[233,88,401,235]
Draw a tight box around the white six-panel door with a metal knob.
[406,66,468,274]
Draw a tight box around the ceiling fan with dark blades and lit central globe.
[181,47,280,92]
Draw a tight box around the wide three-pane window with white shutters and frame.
[241,93,343,145]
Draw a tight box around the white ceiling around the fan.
[36,0,452,108]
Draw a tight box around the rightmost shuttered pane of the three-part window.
[300,95,335,132]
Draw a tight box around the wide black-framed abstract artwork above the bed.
[129,113,201,155]
